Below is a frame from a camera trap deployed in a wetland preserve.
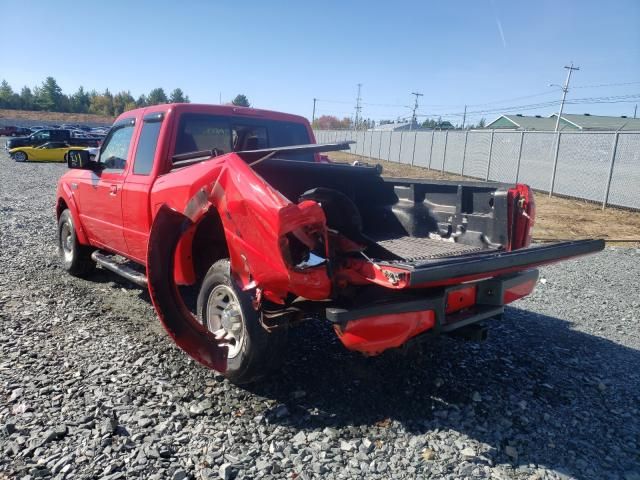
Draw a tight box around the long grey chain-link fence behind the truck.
[315,130,640,210]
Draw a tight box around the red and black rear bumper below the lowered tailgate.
[326,269,538,355]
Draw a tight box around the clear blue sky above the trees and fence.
[0,0,640,123]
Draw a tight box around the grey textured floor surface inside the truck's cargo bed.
[376,236,484,262]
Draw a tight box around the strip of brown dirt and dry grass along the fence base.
[329,152,640,247]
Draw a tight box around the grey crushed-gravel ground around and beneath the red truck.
[0,140,640,480]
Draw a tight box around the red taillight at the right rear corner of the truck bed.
[507,183,536,251]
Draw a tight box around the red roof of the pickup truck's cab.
[116,103,308,124]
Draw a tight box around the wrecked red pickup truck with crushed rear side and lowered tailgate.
[56,104,604,383]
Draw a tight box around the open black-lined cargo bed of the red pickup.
[256,158,510,263]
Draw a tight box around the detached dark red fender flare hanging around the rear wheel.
[147,205,227,372]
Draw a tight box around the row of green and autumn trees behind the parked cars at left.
[0,77,190,117]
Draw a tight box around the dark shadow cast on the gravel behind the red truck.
[249,308,640,478]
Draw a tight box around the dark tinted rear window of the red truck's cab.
[174,113,314,162]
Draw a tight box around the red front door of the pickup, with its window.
[78,119,135,255]
